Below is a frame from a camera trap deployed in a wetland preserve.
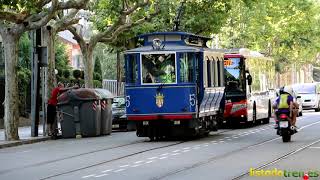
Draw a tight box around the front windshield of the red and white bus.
[224,58,245,94]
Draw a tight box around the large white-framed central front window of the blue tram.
[141,53,176,84]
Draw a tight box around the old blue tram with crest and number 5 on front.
[125,32,224,140]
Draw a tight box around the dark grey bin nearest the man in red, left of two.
[58,88,101,138]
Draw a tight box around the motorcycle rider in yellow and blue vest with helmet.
[273,87,299,131]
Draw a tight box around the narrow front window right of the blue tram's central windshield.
[180,53,195,83]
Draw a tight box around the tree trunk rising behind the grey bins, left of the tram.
[82,49,94,88]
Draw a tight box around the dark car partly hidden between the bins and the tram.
[112,97,135,130]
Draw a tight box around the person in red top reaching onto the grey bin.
[47,82,79,138]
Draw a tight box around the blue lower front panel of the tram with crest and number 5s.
[126,85,196,117]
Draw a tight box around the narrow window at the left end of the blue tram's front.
[126,54,138,84]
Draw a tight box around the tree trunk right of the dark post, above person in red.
[46,30,57,98]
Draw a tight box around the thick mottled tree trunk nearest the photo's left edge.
[3,33,20,141]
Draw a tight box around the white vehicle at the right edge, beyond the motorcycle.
[292,83,320,112]
